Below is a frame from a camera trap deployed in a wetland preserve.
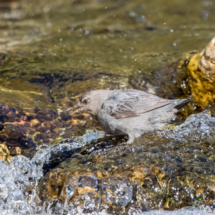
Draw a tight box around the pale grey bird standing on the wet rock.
[68,89,191,144]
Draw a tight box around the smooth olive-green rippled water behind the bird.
[0,0,215,109]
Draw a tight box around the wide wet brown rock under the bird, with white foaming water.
[0,112,215,214]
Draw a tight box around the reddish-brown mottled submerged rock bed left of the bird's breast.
[0,105,97,155]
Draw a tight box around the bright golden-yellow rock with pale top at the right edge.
[177,38,215,108]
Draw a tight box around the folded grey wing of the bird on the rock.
[102,90,174,119]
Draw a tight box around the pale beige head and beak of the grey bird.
[67,90,111,115]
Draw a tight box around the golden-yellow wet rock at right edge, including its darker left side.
[160,38,215,109]
